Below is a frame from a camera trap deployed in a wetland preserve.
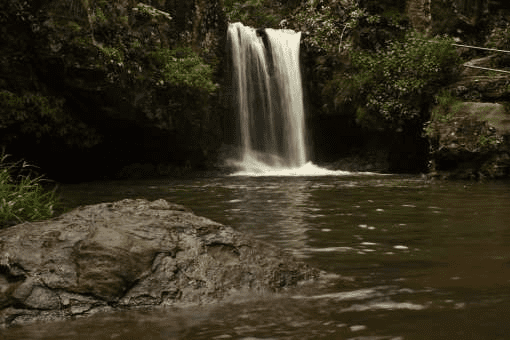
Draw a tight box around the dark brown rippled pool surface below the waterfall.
[5,175,510,340]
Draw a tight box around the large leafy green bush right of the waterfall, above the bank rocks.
[340,33,459,130]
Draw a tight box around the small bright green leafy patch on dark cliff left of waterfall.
[150,48,218,92]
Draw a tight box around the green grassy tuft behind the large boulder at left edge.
[0,154,58,226]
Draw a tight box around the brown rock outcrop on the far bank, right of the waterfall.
[430,102,510,179]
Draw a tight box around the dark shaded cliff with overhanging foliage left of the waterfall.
[0,0,227,178]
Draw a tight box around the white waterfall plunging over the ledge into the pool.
[227,23,307,172]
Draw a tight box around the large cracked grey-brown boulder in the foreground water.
[0,199,319,328]
